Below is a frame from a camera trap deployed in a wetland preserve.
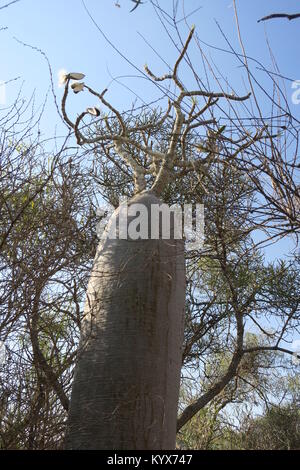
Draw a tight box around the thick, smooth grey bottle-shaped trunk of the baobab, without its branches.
[66,193,185,450]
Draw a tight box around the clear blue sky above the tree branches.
[0,0,300,257]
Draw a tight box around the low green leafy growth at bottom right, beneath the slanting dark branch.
[178,368,300,450]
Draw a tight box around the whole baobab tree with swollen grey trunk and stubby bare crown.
[62,12,298,449]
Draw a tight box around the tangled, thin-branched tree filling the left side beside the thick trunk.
[0,92,96,449]
